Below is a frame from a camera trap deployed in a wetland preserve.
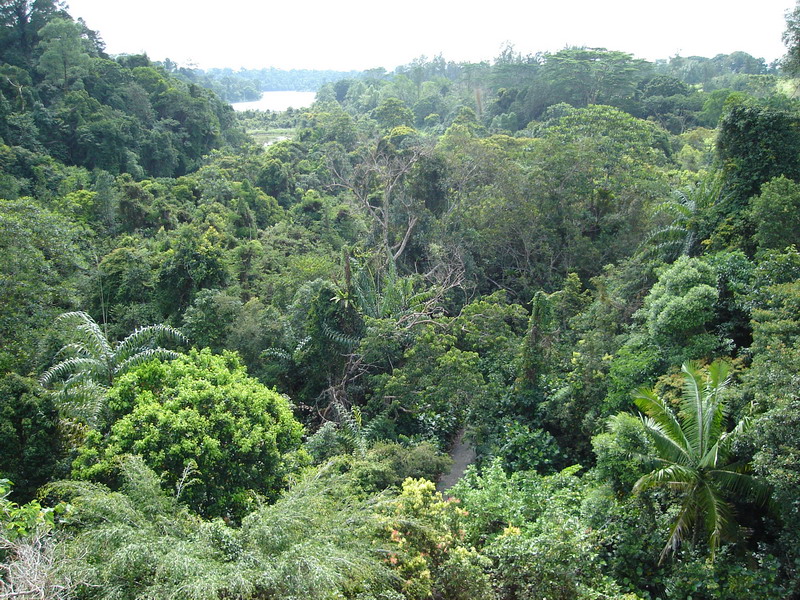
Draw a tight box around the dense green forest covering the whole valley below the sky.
[0,0,800,600]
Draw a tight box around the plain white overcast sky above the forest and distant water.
[67,0,795,70]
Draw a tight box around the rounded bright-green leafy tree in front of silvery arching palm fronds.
[73,349,306,519]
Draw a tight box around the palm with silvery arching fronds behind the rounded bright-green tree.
[40,311,186,423]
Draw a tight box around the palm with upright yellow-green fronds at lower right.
[633,360,768,561]
